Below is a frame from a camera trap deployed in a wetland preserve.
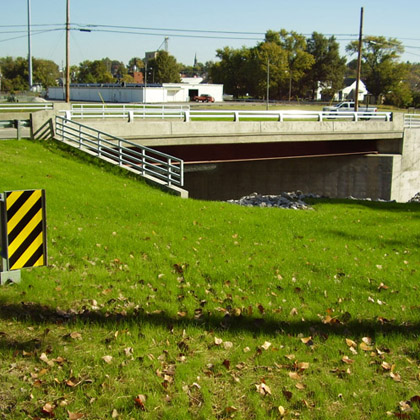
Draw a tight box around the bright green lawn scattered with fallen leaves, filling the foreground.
[0,141,420,420]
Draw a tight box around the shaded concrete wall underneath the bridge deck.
[184,155,394,200]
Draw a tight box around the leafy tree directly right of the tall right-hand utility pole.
[346,36,408,98]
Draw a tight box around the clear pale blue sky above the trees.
[0,0,420,67]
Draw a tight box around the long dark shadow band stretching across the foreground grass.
[0,300,420,346]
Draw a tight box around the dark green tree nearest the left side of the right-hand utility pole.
[302,32,346,100]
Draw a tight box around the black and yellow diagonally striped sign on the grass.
[4,190,47,270]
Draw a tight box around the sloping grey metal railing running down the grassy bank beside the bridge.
[55,116,184,187]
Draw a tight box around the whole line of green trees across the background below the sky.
[0,29,420,107]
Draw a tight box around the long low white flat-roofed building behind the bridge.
[47,78,223,103]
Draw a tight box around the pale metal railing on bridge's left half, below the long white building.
[70,104,190,121]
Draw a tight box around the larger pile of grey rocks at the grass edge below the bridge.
[228,191,320,210]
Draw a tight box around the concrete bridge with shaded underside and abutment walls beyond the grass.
[32,106,420,202]
